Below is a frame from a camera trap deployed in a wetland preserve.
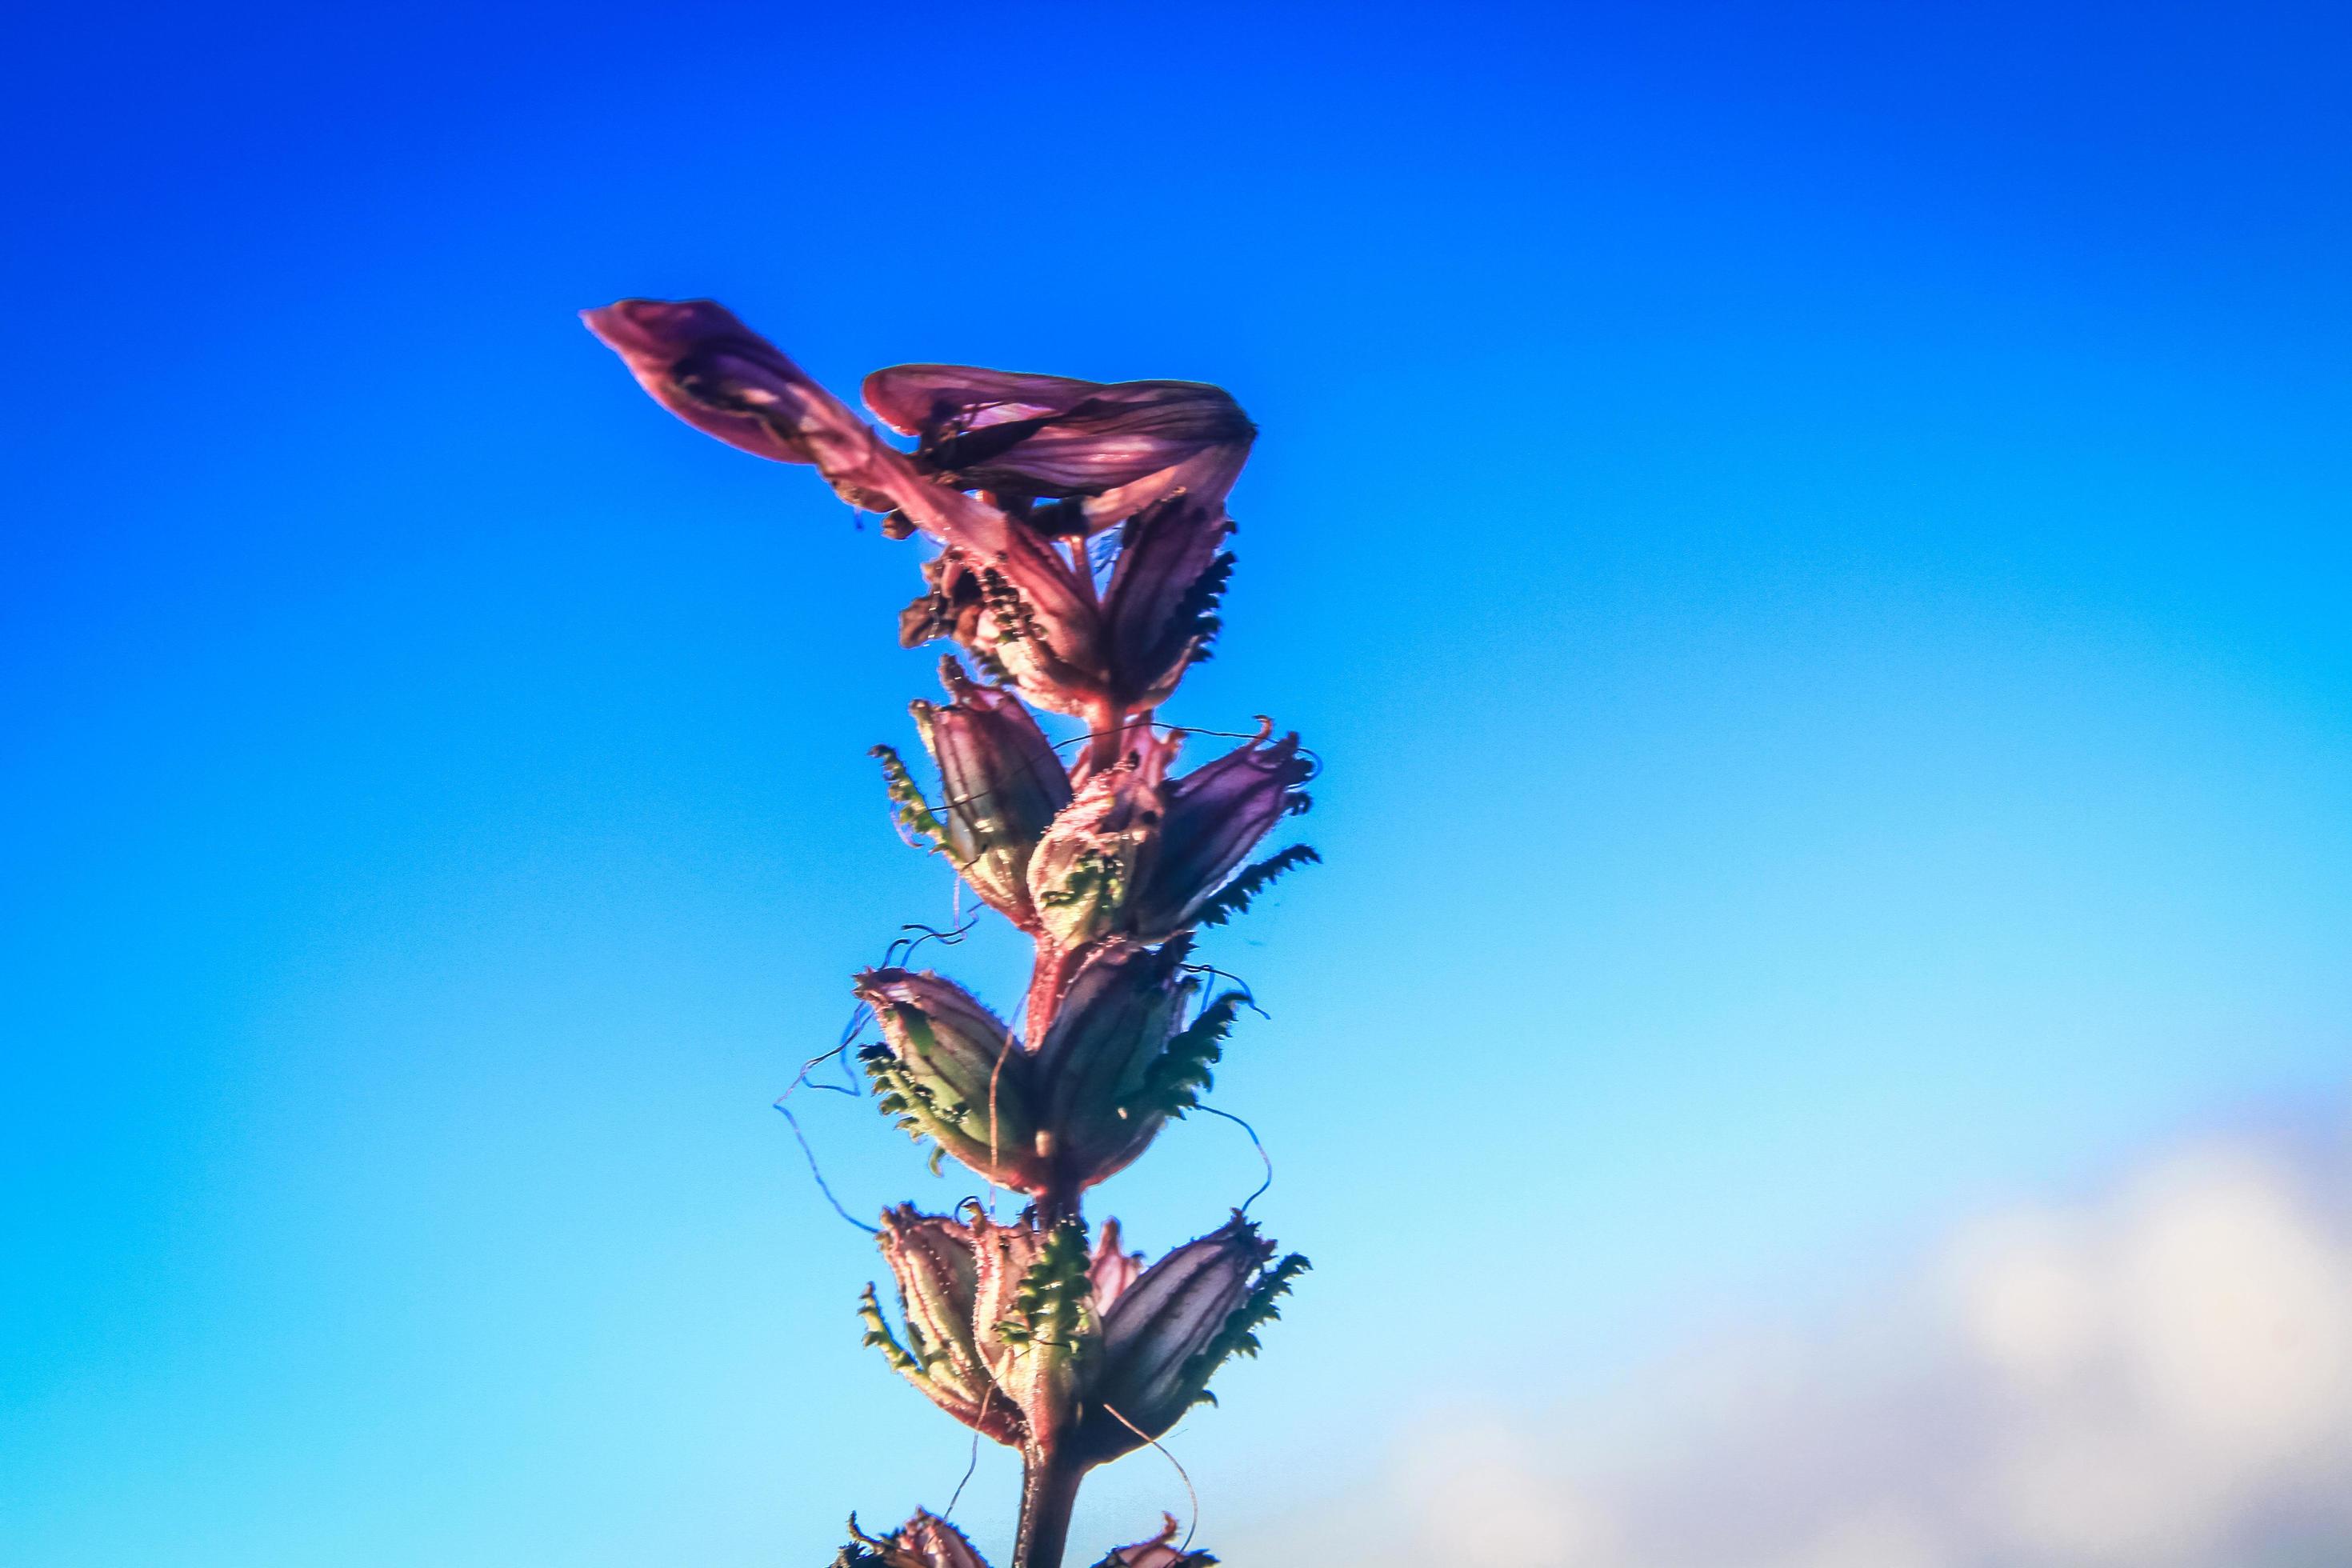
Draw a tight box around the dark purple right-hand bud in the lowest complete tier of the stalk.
[1078,1215,1308,1460]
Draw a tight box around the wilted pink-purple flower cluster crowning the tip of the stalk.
[581,298,1254,719]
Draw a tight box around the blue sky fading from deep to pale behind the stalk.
[0,5,2352,1568]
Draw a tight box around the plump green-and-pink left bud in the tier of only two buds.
[856,969,1049,1190]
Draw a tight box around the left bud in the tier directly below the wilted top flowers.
[875,658,1070,931]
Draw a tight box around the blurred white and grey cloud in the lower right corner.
[1226,1114,2352,1568]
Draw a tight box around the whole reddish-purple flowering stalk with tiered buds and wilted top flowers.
[583,298,1314,1568]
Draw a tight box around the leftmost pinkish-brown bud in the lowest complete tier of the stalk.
[858,1204,1026,1443]
